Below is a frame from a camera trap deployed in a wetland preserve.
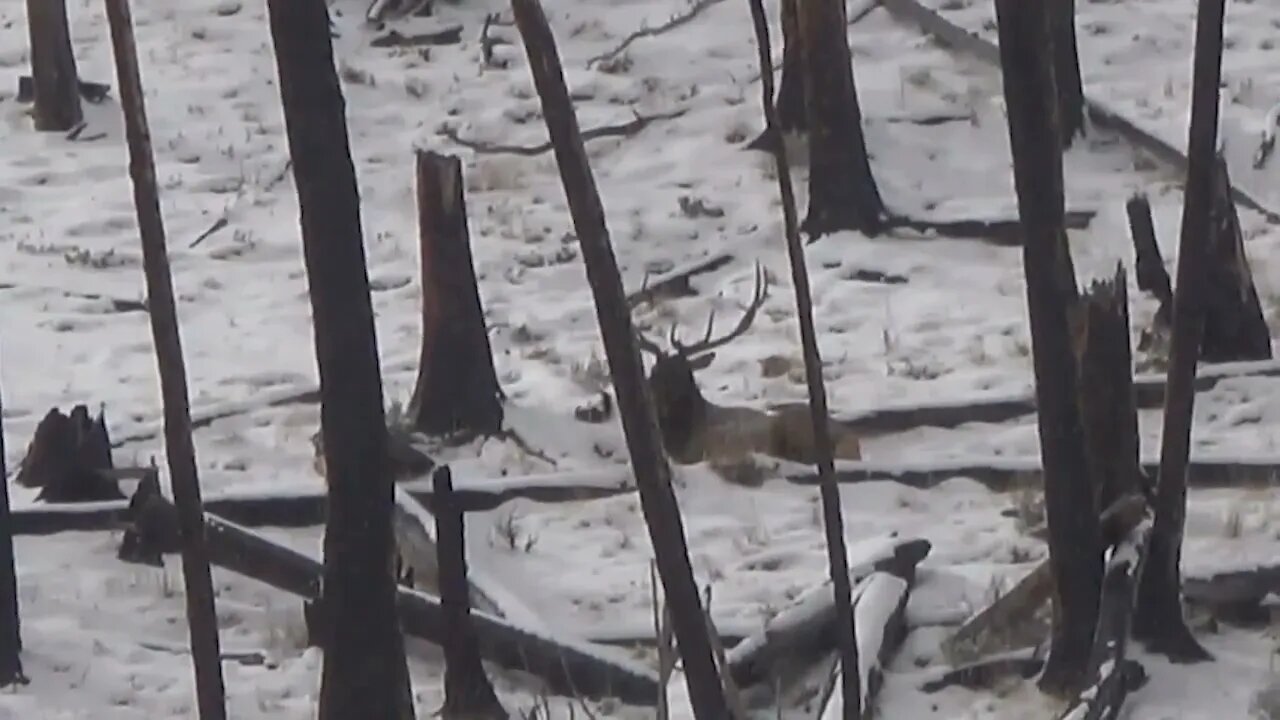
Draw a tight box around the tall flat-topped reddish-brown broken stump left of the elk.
[408,150,503,436]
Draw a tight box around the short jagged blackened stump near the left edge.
[15,405,124,502]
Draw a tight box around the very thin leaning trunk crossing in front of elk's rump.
[750,0,870,719]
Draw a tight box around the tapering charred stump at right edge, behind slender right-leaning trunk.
[1201,156,1271,363]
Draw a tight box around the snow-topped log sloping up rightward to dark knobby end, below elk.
[727,538,931,688]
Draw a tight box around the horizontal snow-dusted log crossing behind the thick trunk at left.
[5,465,635,536]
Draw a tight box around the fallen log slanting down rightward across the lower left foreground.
[122,481,658,706]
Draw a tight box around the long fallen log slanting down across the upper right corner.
[881,0,1280,223]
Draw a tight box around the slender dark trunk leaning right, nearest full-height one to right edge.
[1133,0,1226,662]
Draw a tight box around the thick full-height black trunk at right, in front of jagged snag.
[996,0,1102,694]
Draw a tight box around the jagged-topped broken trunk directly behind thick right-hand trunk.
[1071,266,1146,512]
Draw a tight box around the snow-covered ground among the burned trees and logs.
[0,0,1280,720]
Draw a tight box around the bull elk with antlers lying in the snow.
[636,265,861,465]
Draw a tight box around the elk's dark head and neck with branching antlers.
[636,265,768,462]
